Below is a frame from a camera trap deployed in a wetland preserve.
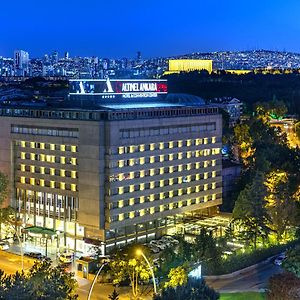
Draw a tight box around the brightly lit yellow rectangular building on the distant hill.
[165,59,212,74]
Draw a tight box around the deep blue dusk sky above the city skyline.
[0,0,300,58]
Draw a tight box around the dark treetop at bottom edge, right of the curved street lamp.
[153,278,220,300]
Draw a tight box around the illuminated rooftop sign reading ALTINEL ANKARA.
[70,79,168,99]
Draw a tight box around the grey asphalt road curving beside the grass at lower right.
[206,262,282,292]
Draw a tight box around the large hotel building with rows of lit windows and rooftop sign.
[0,80,222,253]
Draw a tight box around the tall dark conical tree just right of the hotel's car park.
[233,173,269,249]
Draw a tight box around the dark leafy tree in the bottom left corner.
[0,261,78,300]
